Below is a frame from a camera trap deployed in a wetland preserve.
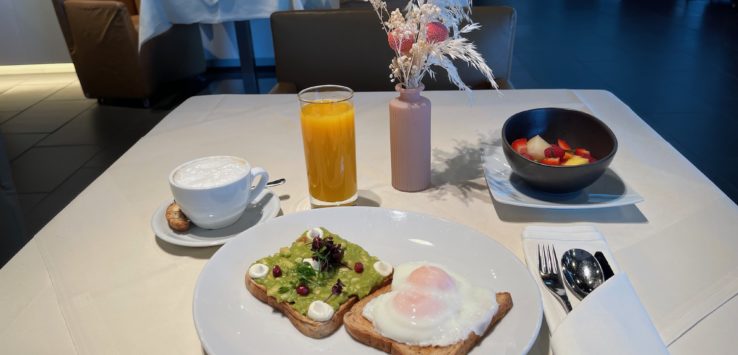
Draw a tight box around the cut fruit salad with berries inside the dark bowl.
[511,135,597,166]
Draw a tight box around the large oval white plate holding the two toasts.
[193,207,542,355]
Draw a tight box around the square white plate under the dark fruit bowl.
[484,139,643,209]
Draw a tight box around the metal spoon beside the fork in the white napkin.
[561,249,605,300]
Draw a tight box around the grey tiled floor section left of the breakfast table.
[0,73,168,264]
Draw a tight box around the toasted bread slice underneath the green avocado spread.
[246,274,392,339]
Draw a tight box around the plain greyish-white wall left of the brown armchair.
[0,0,71,65]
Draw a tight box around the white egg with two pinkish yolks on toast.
[362,262,498,346]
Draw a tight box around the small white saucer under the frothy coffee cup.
[151,189,280,247]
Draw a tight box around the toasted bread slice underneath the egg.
[343,285,513,355]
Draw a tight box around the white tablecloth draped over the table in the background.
[138,0,338,47]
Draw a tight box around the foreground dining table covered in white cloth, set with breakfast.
[0,89,738,354]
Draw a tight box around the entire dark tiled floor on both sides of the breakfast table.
[0,0,738,265]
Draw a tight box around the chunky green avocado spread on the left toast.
[254,228,384,315]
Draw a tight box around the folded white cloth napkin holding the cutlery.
[523,226,668,354]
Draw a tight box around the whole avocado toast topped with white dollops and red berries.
[246,228,392,338]
